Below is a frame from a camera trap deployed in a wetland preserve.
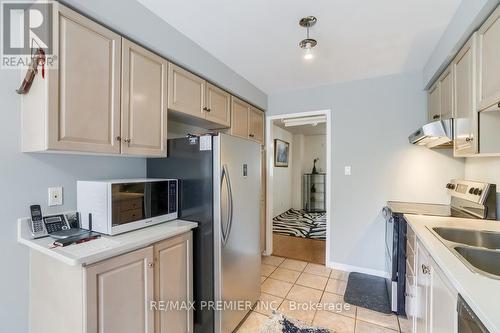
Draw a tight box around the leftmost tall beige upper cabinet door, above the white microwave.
[48,5,121,153]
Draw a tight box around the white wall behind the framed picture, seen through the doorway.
[272,125,293,217]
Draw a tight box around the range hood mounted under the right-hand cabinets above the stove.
[408,119,453,148]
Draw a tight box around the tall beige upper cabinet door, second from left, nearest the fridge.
[121,39,168,156]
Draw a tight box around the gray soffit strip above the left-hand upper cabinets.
[61,0,267,109]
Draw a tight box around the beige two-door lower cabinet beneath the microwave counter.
[30,232,193,333]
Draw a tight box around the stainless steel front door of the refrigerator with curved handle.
[214,135,261,333]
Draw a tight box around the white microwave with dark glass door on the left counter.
[77,179,178,235]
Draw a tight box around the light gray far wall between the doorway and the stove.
[268,73,464,271]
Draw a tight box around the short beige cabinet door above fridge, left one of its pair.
[168,63,206,119]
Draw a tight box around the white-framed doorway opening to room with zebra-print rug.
[264,110,332,265]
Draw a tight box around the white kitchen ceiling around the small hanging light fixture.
[137,0,461,94]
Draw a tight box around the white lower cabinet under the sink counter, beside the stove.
[406,235,458,333]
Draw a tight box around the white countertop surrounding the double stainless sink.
[404,215,500,332]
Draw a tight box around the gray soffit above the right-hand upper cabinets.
[423,0,500,87]
